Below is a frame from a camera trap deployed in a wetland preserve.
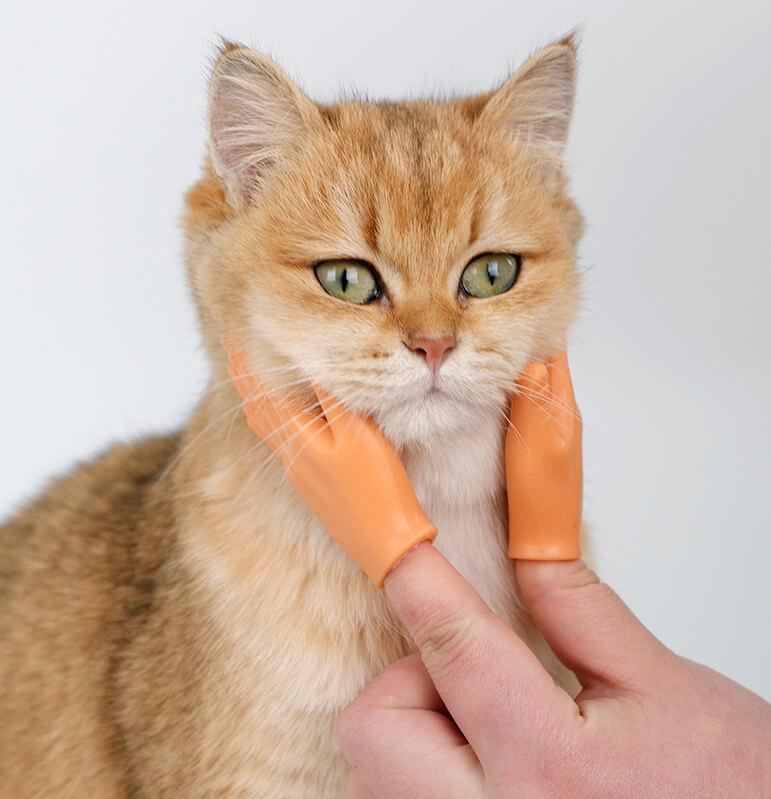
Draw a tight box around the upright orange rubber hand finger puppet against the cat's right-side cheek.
[506,353,583,560]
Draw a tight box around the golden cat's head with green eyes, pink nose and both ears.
[185,37,581,445]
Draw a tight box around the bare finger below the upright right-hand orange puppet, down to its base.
[515,560,672,690]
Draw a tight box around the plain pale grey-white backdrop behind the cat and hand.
[0,0,771,699]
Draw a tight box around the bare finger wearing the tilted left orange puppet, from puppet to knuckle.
[385,544,577,765]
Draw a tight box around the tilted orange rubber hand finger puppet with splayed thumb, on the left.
[222,336,436,587]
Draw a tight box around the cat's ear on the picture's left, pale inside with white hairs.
[209,42,319,208]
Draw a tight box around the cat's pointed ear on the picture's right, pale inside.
[481,34,577,174]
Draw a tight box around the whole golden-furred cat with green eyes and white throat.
[0,36,582,799]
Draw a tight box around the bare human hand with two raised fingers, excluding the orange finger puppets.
[337,545,771,799]
